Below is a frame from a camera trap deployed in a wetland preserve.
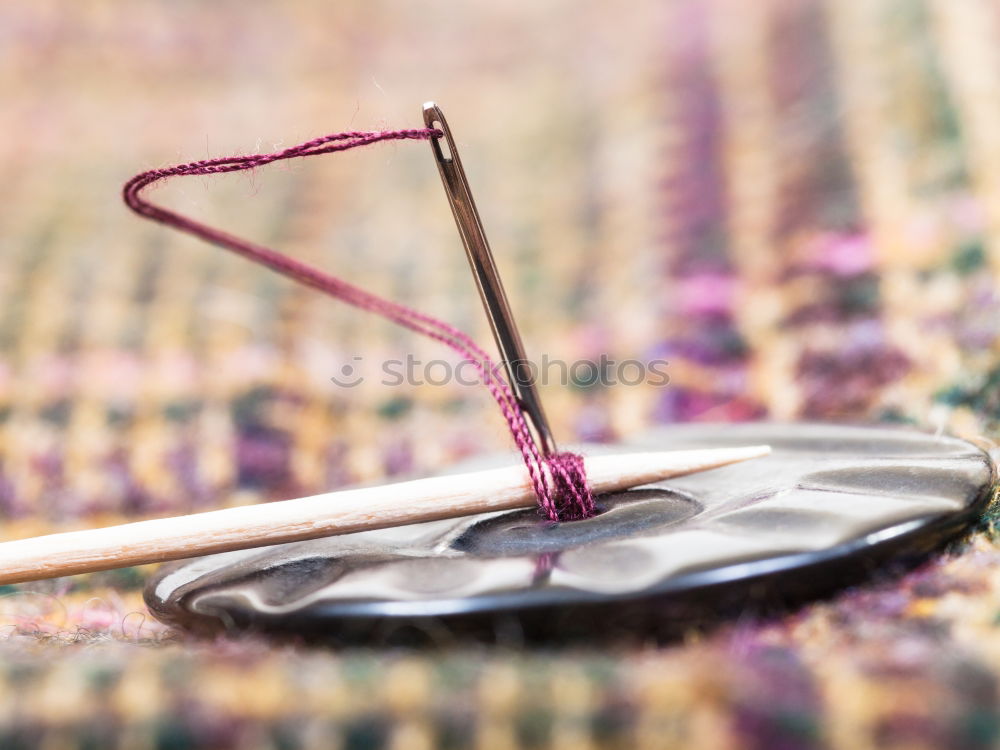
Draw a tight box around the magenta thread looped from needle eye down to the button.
[122,128,595,521]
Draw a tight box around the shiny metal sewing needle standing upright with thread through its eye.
[424,102,556,455]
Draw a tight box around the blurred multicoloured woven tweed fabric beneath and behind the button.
[0,0,1000,750]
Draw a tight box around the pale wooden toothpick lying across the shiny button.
[0,446,770,583]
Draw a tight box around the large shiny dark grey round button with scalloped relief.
[145,424,995,642]
